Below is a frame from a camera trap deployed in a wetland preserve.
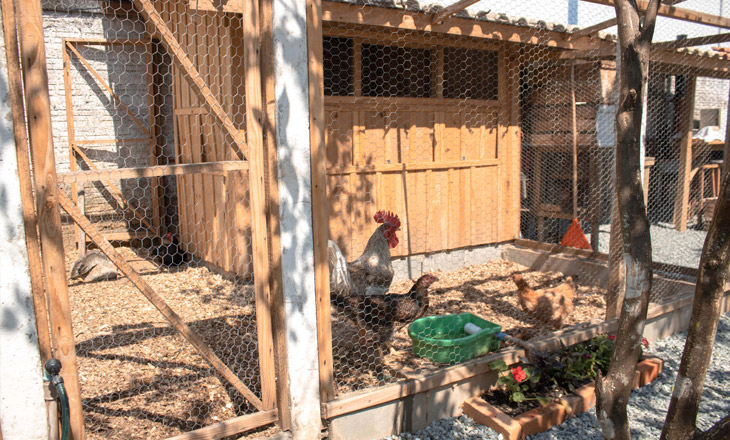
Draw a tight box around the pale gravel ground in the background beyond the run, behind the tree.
[588,223,707,268]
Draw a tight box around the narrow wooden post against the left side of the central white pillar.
[260,0,291,431]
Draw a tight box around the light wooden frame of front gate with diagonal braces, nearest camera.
[7,0,289,439]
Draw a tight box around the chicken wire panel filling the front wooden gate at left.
[43,0,275,439]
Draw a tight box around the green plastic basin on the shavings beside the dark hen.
[408,313,502,364]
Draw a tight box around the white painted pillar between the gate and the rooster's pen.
[273,0,321,440]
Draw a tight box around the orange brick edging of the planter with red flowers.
[463,355,664,440]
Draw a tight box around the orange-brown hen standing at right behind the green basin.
[512,274,575,330]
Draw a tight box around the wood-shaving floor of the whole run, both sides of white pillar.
[65,225,605,440]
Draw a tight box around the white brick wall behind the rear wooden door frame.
[43,5,175,227]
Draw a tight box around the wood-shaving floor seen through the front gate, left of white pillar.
[65,225,276,440]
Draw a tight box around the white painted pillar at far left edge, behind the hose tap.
[0,11,48,440]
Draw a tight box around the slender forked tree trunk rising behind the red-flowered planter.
[596,0,659,440]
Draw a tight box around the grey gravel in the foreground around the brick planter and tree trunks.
[384,313,730,440]
